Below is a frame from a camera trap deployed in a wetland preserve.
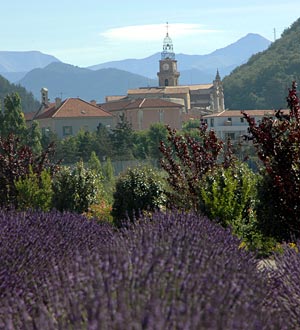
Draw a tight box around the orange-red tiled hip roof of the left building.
[34,98,112,119]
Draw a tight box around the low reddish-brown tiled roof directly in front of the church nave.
[101,98,184,111]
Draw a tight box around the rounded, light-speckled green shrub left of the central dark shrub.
[53,161,103,213]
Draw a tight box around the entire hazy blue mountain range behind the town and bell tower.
[0,33,271,102]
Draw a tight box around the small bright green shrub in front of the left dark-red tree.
[15,166,53,212]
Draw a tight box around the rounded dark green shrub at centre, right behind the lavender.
[112,166,166,226]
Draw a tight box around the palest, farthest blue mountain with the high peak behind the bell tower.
[89,33,271,81]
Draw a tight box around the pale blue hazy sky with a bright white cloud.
[0,0,300,67]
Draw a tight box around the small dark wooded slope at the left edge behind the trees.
[0,75,39,113]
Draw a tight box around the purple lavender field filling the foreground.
[0,211,300,330]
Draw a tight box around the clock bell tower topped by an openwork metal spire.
[157,23,180,87]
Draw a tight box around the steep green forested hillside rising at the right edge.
[223,18,300,110]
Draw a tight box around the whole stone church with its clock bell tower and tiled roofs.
[100,26,225,130]
